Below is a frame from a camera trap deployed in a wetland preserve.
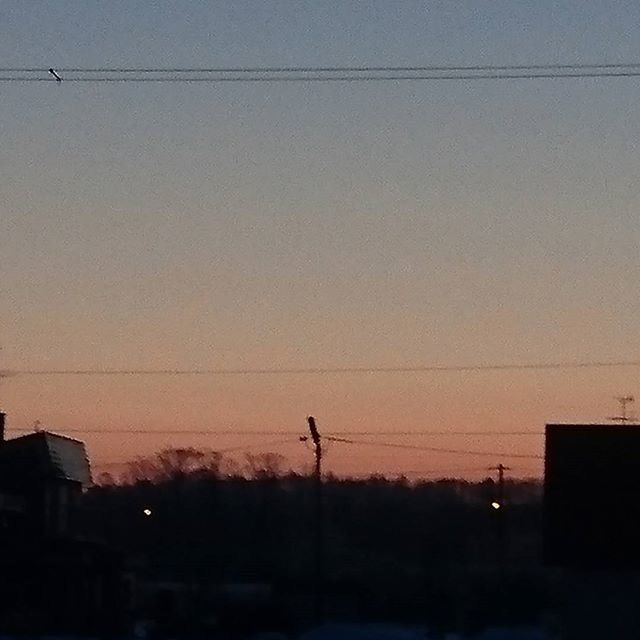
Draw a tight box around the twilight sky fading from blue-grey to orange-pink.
[0,0,640,475]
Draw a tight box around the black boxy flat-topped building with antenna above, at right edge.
[544,424,640,570]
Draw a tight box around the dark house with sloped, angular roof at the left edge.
[0,413,123,633]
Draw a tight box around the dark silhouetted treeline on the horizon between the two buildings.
[83,449,546,626]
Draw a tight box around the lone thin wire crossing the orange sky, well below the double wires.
[1,360,640,377]
